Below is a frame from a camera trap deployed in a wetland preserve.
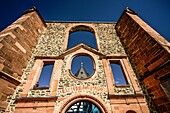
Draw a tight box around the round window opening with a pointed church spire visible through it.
[71,55,94,79]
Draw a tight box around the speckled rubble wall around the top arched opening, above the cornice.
[35,22,126,56]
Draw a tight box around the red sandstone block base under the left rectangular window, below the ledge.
[15,96,57,113]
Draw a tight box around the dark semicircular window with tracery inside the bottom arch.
[66,101,102,113]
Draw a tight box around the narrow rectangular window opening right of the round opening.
[110,62,128,85]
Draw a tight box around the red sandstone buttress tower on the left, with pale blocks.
[0,8,45,110]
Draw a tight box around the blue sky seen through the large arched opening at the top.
[67,31,97,50]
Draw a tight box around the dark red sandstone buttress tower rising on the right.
[116,9,170,112]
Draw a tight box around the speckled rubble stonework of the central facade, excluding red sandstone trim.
[8,22,133,112]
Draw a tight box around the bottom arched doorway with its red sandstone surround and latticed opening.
[59,94,110,113]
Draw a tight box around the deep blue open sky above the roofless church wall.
[0,0,170,41]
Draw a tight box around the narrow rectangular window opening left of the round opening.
[37,62,54,87]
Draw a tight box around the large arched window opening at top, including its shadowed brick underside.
[67,26,97,50]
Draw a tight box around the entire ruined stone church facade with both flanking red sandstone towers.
[0,8,170,113]
